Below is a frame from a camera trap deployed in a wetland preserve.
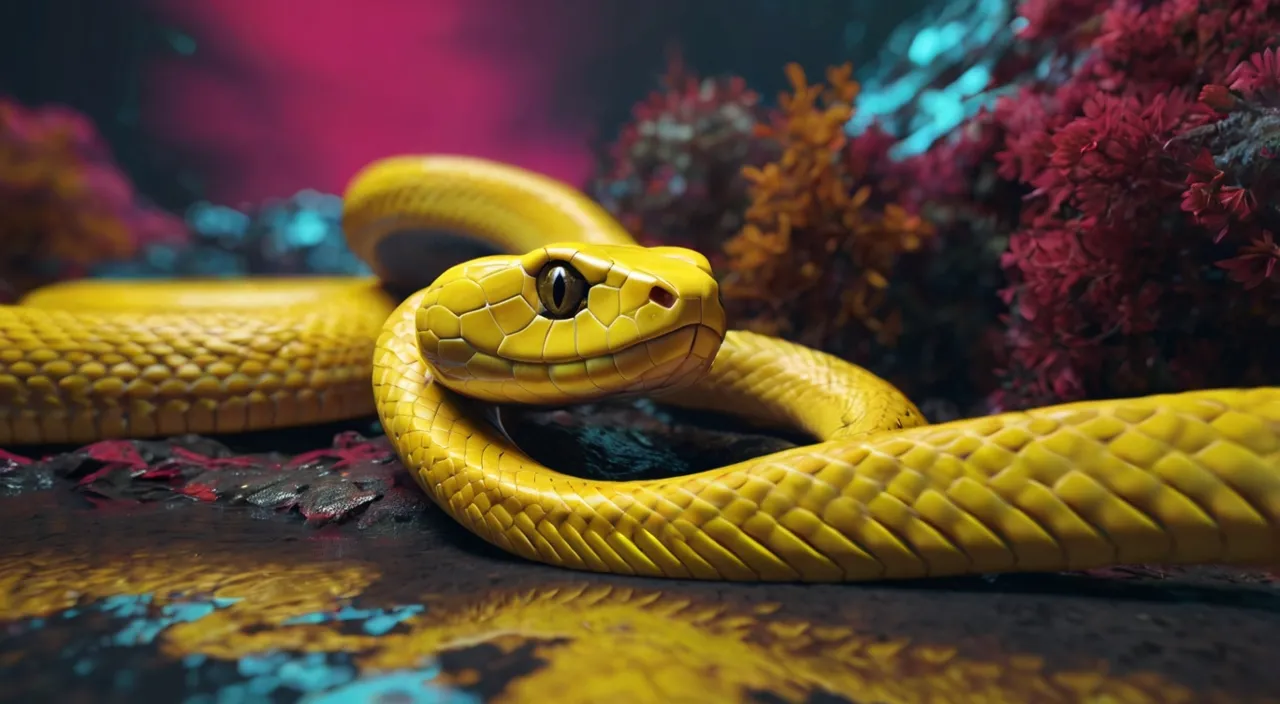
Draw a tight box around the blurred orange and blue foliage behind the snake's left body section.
[0,93,369,293]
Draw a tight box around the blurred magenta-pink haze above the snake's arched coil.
[147,0,650,205]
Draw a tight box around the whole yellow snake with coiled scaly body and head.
[0,156,1280,581]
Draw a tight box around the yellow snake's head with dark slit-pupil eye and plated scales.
[416,243,724,404]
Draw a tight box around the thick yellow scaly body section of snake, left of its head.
[0,279,390,445]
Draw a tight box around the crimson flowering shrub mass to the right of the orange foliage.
[788,0,1280,413]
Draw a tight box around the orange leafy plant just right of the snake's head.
[723,64,933,349]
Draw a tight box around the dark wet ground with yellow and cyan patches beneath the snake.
[0,404,1280,704]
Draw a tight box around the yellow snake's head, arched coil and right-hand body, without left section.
[346,157,1280,581]
